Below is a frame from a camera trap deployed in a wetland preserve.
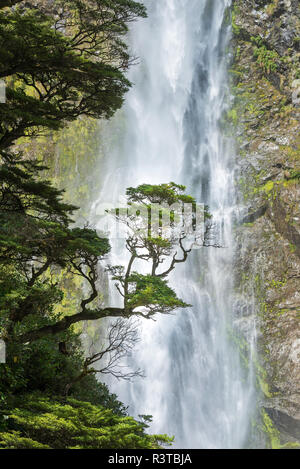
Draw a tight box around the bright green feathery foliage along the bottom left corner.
[0,394,172,449]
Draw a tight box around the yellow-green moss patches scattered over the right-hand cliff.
[229,0,300,449]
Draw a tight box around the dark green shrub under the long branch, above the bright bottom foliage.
[0,318,127,416]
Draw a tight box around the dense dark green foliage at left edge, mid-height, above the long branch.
[0,155,110,341]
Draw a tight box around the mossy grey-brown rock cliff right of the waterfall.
[232,0,300,447]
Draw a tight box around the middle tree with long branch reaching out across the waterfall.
[0,166,212,343]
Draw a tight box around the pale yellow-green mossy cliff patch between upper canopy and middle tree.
[18,117,102,218]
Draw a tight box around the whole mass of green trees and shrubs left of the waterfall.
[0,0,187,448]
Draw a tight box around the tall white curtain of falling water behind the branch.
[94,0,253,448]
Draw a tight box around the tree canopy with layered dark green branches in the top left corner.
[0,0,146,150]
